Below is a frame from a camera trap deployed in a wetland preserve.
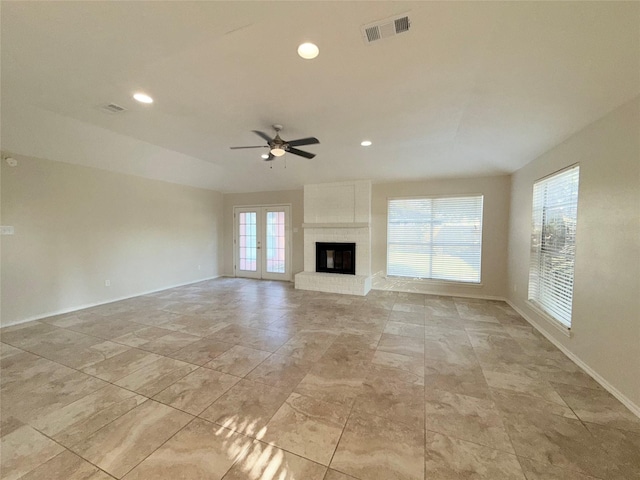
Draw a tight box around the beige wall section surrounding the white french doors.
[224,190,304,280]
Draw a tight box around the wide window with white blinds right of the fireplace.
[387,195,483,283]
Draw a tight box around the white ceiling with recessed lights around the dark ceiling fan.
[1,1,640,192]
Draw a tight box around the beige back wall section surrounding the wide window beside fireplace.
[371,175,510,297]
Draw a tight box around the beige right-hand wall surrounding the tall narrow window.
[509,98,640,408]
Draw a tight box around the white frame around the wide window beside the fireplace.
[385,193,485,287]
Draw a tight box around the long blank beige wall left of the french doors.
[1,156,222,325]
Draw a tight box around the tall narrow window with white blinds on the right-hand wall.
[529,165,580,328]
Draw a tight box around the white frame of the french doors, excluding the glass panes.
[232,203,293,282]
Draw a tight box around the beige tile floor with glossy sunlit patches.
[0,279,640,480]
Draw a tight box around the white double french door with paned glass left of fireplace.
[233,205,291,280]
